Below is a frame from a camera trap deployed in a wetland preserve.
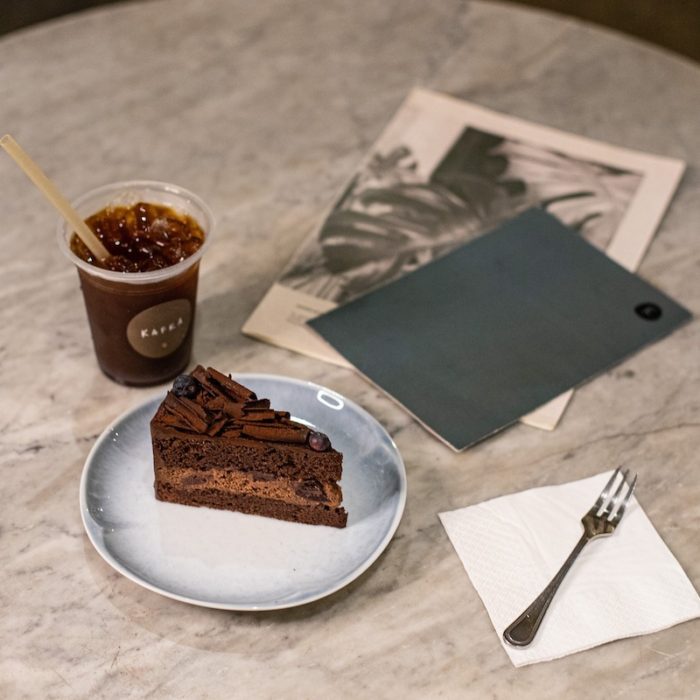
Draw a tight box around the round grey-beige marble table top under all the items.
[0,0,700,700]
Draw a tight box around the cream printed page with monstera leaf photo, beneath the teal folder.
[242,89,684,430]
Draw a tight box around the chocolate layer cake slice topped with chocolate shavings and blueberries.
[151,366,347,527]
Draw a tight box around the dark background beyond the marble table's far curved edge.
[0,0,700,62]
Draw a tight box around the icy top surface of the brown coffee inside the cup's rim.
[70,202,204,272]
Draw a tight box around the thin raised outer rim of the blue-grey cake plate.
[79,372,408,612]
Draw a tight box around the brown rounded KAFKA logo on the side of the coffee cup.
[126,299,192,358]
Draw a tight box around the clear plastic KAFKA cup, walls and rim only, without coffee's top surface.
[57,180,214,386]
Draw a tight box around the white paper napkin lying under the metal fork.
[440,472,700,666]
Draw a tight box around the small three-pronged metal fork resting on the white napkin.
[503,467,637,647]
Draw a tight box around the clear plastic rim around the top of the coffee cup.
[56,180,214,284]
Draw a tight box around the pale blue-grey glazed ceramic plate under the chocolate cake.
[80,374,406,610]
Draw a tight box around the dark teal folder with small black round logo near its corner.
[309,209,691,450]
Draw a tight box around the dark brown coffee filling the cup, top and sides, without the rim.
[70,202,205,386]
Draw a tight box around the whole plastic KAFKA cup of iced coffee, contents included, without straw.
[59,182,211,385]
